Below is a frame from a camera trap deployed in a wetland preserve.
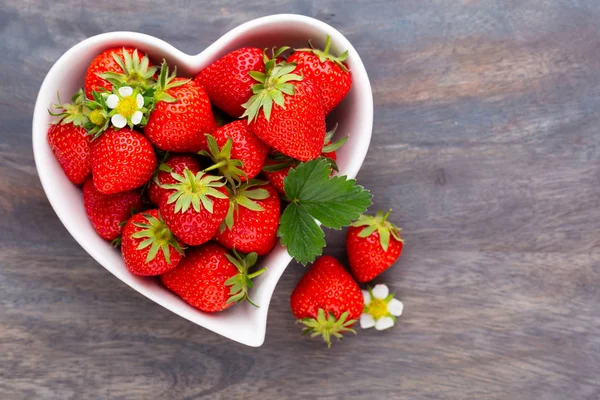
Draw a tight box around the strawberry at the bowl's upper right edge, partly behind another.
[288,35,352,115]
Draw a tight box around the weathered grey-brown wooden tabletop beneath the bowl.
[0,0,600,400]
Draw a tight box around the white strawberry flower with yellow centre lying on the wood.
[360,284,404,331]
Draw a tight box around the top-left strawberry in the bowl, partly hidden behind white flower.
[84,47,156,99]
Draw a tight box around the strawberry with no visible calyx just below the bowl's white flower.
[91,128,156,194]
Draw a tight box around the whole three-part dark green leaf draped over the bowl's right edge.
[277,158,371,264]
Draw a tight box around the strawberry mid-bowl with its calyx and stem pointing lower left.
[200,120,269,182]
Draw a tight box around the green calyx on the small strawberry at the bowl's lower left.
[131,214,184,264]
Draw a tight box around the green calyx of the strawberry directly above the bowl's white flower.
[98,49,157,90]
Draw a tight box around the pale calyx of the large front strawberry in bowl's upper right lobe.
[242,47,302,123]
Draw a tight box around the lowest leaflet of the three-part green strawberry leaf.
[277,203,325,264]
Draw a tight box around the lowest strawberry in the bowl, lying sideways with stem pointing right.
[160,243,265,312]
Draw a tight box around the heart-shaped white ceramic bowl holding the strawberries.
[33,14,373,346]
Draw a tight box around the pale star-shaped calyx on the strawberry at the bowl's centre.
[161,169,227,214]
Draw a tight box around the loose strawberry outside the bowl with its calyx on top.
[346,210,404,282]
